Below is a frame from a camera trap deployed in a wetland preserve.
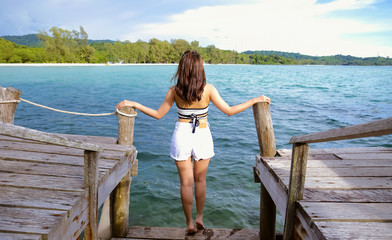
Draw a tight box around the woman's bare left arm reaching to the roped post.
[116,88,174,120]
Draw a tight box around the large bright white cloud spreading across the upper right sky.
[122,0,392,56]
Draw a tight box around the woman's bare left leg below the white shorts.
[175,158,196,231]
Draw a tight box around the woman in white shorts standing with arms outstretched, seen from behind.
[117,50,271,233]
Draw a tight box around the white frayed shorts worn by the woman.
[170,122,215,161]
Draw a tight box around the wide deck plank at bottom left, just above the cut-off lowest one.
[0,206,67,234]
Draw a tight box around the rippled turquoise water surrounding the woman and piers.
[0,65,392,230]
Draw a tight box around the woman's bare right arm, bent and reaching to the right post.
[209,84,271,116]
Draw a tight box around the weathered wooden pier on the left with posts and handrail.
[0,86,137,240]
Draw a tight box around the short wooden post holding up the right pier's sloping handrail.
[283,143,309,240]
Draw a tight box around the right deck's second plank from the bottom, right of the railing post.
[299,201,392,222]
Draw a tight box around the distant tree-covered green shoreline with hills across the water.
[0,27,392,66]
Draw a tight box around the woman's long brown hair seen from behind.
[172,50,206,103]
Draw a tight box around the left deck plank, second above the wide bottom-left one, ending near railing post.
[0,173,84,192]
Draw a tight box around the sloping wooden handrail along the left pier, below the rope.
[0,122,102,151]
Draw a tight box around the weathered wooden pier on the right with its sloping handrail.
[255,118,392,239]
